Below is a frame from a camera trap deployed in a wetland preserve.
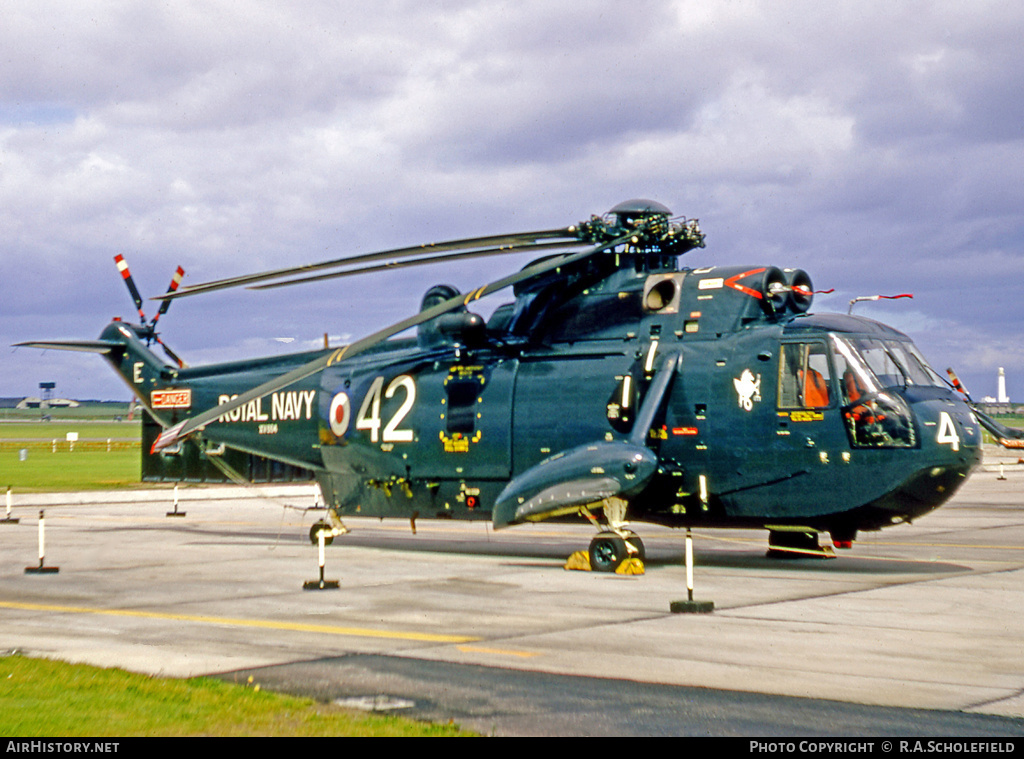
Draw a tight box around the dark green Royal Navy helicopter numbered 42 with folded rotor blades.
[22,200,1019,571]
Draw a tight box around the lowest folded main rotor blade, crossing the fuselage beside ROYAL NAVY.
[152,233,633,453]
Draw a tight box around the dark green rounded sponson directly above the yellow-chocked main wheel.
[492,440,657,530]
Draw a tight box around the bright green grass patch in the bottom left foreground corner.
[0,656,470,737]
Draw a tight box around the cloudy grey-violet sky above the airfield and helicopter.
[0,0,1024,400]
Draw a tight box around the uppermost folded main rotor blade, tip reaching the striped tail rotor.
[154,227,580,300]
